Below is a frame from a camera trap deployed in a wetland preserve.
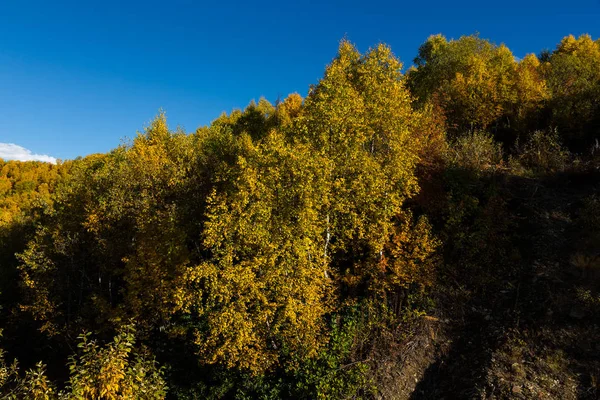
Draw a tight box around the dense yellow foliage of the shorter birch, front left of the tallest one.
[182,131,330,372]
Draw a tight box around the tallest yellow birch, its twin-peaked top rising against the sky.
[298,41,436,292]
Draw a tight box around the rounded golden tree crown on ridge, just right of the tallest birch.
[408,35,517,133]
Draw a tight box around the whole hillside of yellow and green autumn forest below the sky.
[0,35,600,400]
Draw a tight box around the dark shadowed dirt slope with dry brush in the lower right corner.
[408,173,600,400]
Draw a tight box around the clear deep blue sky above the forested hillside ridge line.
[0,0,600,159]
